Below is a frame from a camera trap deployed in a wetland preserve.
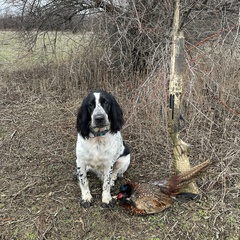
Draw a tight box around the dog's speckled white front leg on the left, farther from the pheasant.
[77,164,92,207]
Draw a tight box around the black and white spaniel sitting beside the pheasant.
[76,91,130,207]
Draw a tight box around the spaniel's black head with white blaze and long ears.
[77,91,124,138]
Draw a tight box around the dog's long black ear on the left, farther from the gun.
[77,98,91,138]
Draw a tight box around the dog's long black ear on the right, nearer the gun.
[109,96,124,133]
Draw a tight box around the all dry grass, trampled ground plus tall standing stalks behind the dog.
[0,31,240,240]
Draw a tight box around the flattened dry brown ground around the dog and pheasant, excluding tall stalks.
[0,78,240,240]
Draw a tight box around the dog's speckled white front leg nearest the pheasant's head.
[102,165,113,208]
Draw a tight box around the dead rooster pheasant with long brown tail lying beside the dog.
[116,160,210,214]
